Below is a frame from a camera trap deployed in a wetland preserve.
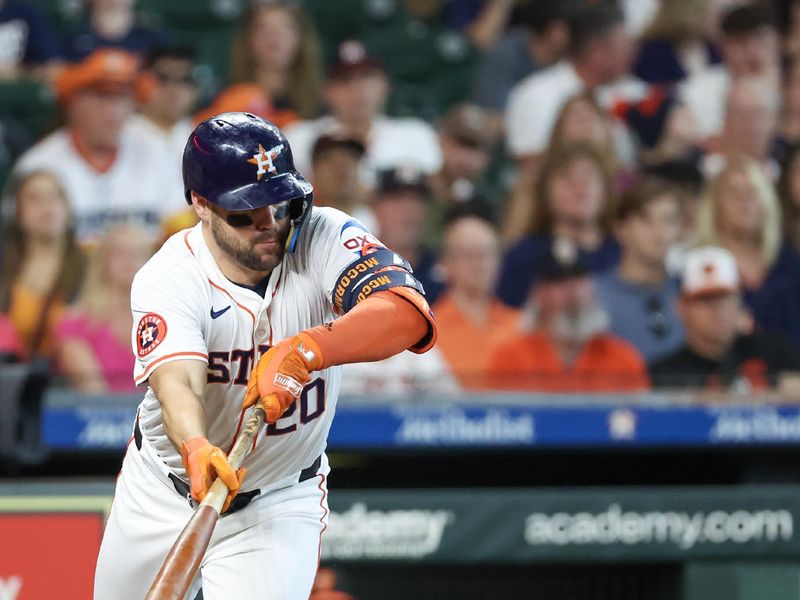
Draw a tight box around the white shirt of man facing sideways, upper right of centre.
[506,60,647,160]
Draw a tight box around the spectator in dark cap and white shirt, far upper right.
[680,3,780,138]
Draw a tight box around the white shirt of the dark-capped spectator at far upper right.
[678,65,730,138]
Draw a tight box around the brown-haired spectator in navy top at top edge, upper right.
[633,0,721,84]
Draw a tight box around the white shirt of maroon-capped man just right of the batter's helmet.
[284,116,442,187]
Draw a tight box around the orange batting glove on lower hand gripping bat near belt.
[181,438,247,512]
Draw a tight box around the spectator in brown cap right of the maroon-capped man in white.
[431,104,499,210]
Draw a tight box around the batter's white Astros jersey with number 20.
[131,208,377,490]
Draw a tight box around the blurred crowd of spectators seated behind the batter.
[0,0,800,398]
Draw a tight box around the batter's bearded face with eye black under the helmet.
[208,202,289,272]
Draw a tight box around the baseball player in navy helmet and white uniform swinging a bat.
[94,113,436,600]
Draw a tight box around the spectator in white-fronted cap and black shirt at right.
[650,246,800,394]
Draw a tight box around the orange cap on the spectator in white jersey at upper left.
[55,48,139,104]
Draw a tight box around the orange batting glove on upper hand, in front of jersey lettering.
[243,332,323,423]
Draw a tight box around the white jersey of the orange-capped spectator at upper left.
[14,128,186,244]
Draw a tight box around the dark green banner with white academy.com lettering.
[323,486,800,563]
